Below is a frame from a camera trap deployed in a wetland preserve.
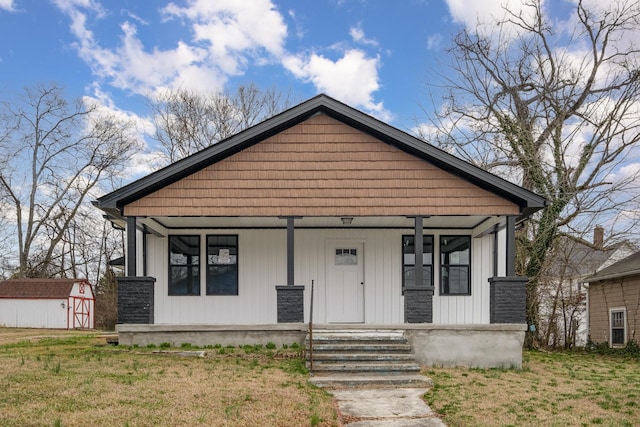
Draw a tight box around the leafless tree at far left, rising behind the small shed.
[0,84,137,277]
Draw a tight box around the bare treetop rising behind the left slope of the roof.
[149,84,290,162]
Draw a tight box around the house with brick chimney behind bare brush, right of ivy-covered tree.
[539,226,635,347]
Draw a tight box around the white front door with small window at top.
[326,241,365,323]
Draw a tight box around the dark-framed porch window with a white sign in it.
[207,235,238,295]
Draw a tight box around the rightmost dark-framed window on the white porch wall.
[440,236,471,295]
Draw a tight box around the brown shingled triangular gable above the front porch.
[124,114,520,216]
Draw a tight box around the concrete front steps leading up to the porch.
[305,329,432,388]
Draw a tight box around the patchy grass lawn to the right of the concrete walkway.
[423,352,640,427]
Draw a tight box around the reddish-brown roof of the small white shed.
[0,279,86,299]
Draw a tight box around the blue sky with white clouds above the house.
[0,0,552,129]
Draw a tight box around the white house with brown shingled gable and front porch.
[95,95,545,366]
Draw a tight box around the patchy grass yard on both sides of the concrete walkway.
[0,328,640,427]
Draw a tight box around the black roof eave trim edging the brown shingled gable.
[94,95,546,220]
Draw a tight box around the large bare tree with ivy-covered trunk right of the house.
[422,0,640,344]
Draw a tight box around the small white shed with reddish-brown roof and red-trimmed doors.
[0,279,95,329]
